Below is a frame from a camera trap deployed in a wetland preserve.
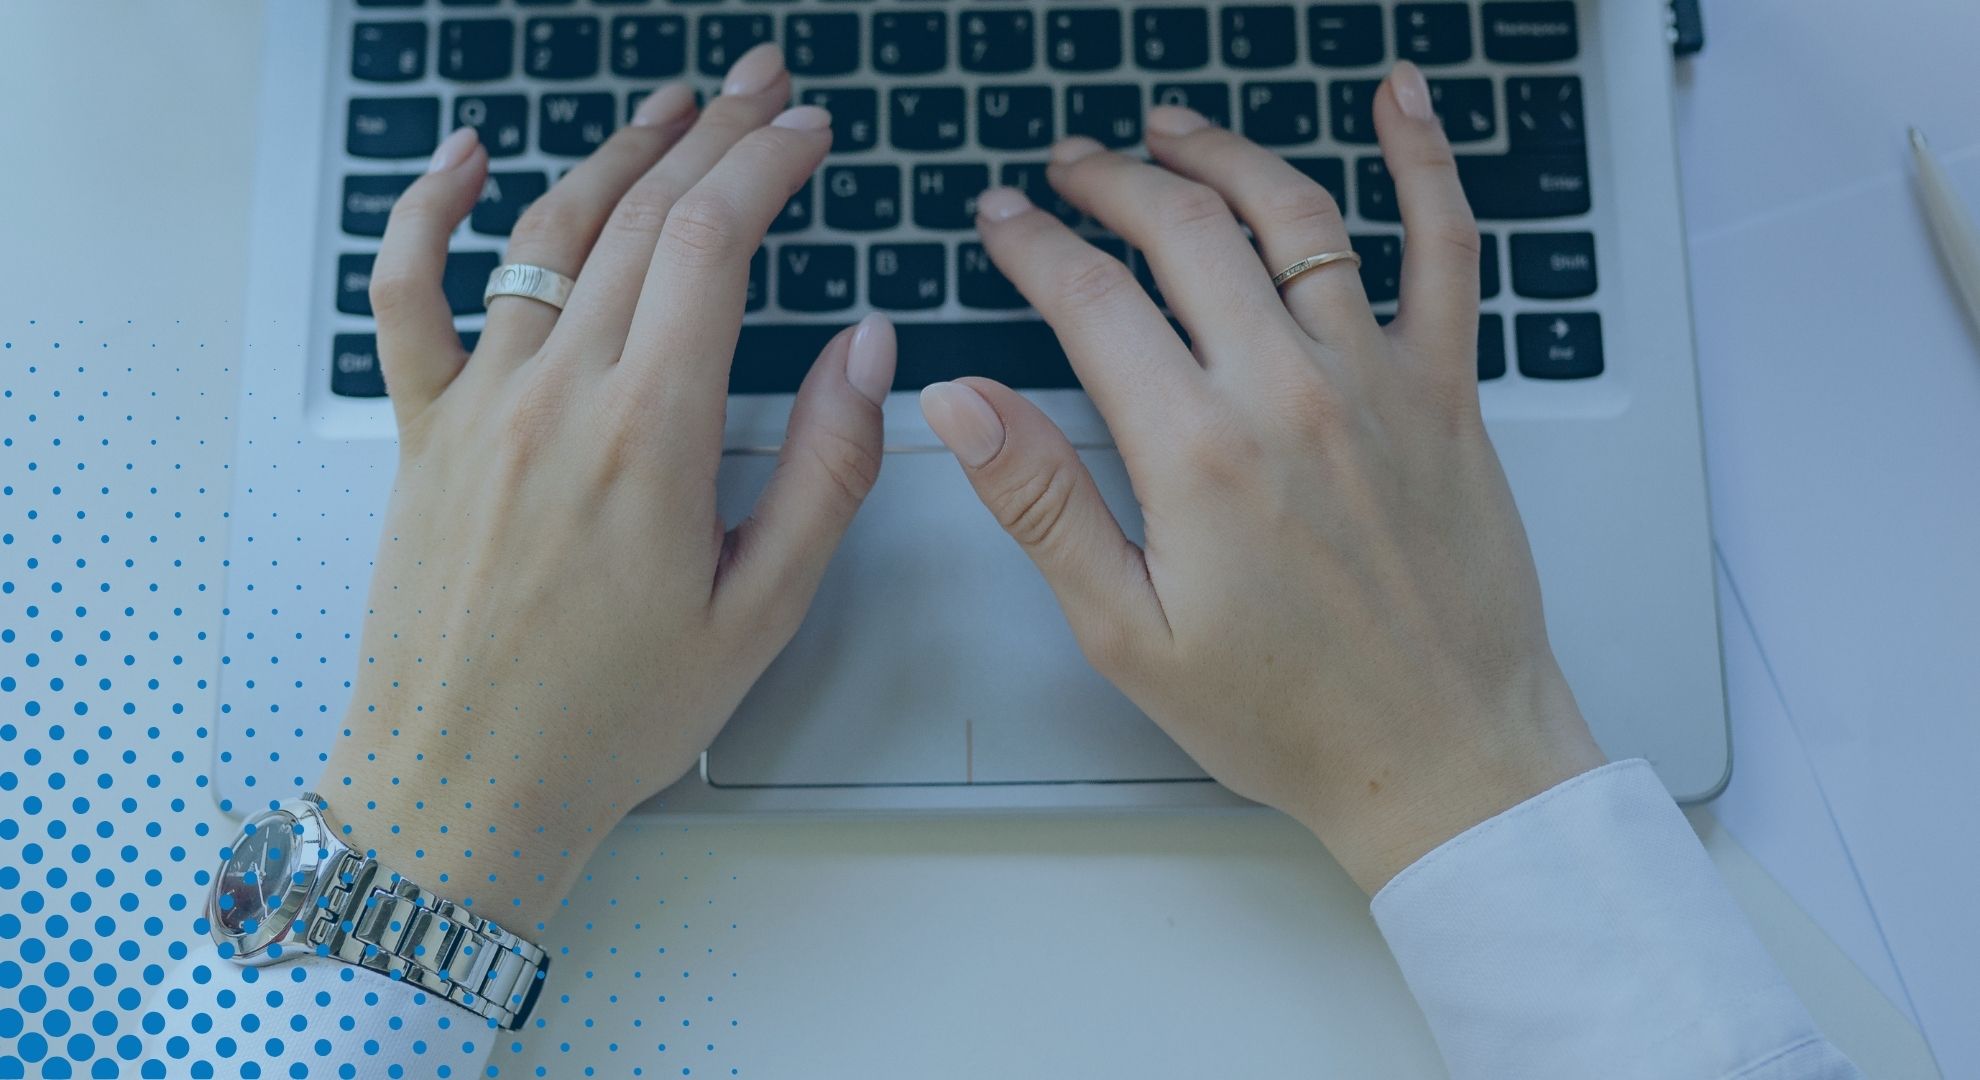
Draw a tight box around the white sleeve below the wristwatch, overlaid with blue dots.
[141,937,503,1080]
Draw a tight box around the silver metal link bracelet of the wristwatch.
[305,850,550,1030]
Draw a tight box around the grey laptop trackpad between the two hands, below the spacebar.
[709,450,1204,787]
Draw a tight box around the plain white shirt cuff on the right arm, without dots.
[1374,759,1861,1080]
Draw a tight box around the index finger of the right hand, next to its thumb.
[976,188,1202,445]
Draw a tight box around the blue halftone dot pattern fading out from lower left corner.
[0,319,746,1078]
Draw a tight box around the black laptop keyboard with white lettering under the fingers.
[323,0,1604,398]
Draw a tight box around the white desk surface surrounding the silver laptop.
[0,0,1948,1076]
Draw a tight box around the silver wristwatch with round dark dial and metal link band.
[206,793,550,1030]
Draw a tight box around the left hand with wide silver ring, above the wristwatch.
[317,46,895,937]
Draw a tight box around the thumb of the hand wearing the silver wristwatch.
[715,315,895,628]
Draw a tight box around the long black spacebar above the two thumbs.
[729,319,1079,394]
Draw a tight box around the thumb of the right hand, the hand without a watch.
[921,378,1170,672]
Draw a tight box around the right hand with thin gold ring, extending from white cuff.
[923,63,1602,892]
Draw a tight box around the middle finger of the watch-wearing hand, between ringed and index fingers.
[552,44,790,359]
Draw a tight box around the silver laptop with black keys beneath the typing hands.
[214,0,1731,814]
